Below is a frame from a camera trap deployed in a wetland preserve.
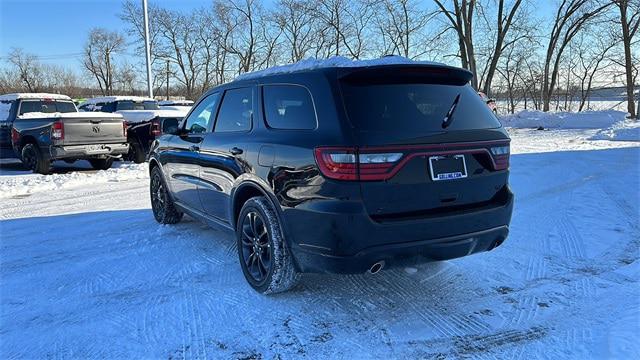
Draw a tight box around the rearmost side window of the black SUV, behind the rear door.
[262,85,317,130]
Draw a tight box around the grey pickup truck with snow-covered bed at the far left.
[0,93,129,174]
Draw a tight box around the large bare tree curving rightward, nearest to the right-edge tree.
[542,0,611,111]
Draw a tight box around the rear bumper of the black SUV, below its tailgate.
[284,187,513,274]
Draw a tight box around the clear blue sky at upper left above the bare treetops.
[0,0,212,66]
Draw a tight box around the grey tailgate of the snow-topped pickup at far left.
[60,113,127,145]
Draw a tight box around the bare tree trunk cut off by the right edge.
[613,0,640,119]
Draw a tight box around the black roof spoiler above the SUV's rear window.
[338,64,473,86]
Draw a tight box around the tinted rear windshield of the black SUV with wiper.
[342,84,500,139]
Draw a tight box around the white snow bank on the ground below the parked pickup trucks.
[0,163,149,199]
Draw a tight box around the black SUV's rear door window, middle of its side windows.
[215,88,253,132]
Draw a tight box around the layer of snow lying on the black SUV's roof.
[236,55,444,80]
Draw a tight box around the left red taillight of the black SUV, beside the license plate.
[315,148,403,181]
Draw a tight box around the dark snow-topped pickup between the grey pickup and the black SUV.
[80,96,189,163]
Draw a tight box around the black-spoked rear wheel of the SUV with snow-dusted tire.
[236,196,300,294]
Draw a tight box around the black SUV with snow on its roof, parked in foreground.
[149,64,513,293]
